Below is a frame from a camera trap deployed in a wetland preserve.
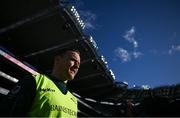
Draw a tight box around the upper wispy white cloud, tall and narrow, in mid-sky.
[123,26,138,48]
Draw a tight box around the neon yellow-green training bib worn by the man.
[29,74,77,118]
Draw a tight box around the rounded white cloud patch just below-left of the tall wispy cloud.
[115,47,131,62]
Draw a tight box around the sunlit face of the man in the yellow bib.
[57,51,80,80]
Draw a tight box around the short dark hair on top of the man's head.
[55,48,80,56]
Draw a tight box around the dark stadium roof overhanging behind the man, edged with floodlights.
[0,0,114,98]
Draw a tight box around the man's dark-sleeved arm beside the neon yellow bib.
[0,76,36,116]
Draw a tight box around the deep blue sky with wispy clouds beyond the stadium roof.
[70,0,180,87]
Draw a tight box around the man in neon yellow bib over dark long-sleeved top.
[1,49,80,117]
